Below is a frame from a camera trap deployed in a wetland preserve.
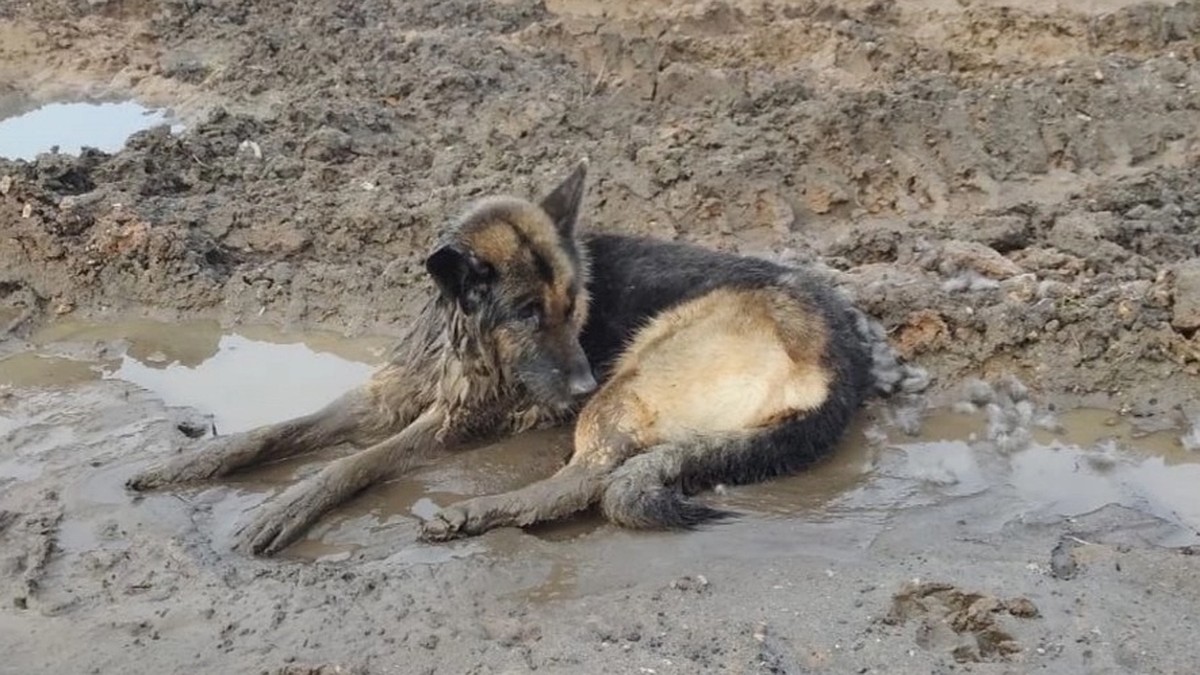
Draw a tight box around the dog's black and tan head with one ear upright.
[425,160,596,407]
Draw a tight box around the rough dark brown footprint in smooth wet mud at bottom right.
[883,581,1038,663]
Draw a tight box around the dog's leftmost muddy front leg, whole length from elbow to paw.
[126,366,428,491]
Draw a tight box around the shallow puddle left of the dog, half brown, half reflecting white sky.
[0,321,390,434]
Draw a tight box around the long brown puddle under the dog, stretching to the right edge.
[265,410,1200,602]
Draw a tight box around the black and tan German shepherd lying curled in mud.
[128,161,925,555]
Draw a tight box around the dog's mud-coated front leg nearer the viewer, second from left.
[235,407,444,555]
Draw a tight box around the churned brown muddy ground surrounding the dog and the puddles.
[0,0,1200,673]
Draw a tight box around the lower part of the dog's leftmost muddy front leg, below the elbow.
[126,392,367,490]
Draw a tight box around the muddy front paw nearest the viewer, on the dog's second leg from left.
[234,476,331,556]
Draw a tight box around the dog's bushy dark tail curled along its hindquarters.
[600,398,856,530]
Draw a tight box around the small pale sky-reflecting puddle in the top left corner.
[0,101,182,160]
